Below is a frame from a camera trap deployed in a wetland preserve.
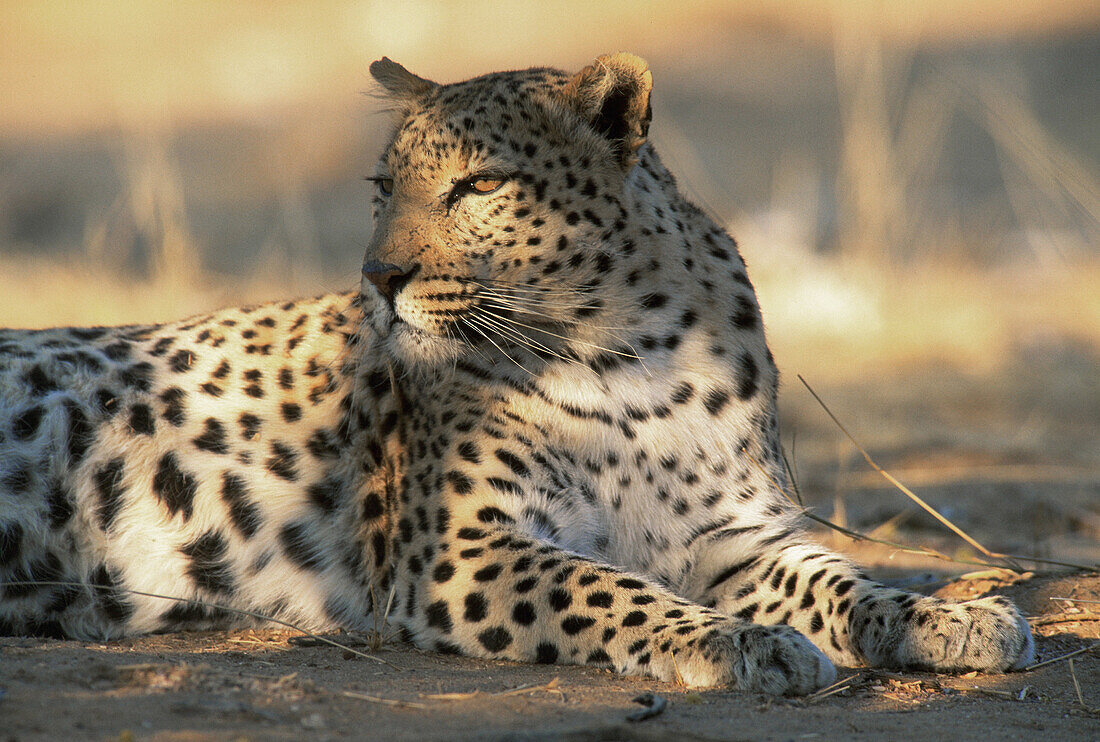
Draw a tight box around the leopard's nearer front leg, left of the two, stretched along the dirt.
[395,523,835,694]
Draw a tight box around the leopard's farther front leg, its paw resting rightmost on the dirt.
[686,524,1034,672]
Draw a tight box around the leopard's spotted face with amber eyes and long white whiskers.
[362,57,648,368]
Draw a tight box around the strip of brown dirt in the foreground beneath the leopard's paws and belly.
[0,573,1100,742]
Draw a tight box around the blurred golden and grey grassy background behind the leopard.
[0,0,1100,566]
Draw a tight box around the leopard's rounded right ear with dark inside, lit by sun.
[562,52,653,170]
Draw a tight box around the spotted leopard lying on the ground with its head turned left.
[0,53,1034,695]
